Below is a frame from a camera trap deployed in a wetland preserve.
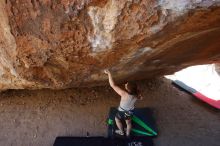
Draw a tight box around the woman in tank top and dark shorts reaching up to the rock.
[104,70,142,137]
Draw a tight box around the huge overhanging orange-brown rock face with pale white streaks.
[0,0,220,90]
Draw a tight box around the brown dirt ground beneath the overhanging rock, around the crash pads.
[0,79,220,146]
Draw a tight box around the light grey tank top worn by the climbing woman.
[118,94,137,111]
